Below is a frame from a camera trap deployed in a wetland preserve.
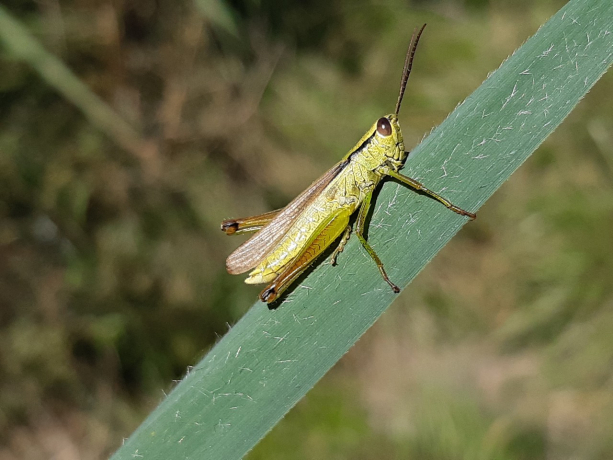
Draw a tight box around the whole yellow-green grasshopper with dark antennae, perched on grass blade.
[221,24,477,304]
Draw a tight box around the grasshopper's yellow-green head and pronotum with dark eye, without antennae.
[345,114,407,171]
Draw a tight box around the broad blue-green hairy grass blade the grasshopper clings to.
[113,0,613,460]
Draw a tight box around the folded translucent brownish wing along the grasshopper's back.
[226,160,348,275]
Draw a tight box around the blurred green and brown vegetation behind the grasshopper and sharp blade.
[0,0,613,460]
